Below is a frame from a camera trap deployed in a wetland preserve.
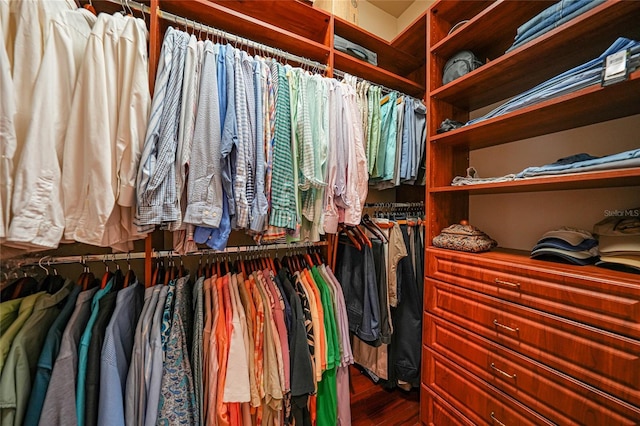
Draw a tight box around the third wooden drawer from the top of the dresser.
[423,314,640,426]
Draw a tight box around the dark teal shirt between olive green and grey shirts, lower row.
[24,286,82,426]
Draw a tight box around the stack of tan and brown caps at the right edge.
[593,209,640,273]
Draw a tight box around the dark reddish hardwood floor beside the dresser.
[350,366,420,426]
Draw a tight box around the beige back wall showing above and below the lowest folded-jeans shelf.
[469,115,640,250]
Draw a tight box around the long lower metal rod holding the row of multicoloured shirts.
[19,241,329,267]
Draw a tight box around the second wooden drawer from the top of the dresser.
[423,280,640,406]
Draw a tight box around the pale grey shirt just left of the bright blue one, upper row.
[184,41,222,227]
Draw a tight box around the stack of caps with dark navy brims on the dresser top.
[531,226,598,265]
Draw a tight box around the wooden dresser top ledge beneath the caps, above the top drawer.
[427,245,640,287]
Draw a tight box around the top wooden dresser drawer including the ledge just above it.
[427,248,640,339]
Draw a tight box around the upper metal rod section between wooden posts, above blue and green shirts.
[154,8,327,71]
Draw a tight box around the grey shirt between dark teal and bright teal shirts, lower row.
[39,288,98,426]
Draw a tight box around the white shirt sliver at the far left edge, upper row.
[0,23,18,238]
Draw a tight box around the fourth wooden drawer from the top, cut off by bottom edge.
[422,347,553,426]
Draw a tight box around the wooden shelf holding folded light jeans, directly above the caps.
[429,167,640,195]
